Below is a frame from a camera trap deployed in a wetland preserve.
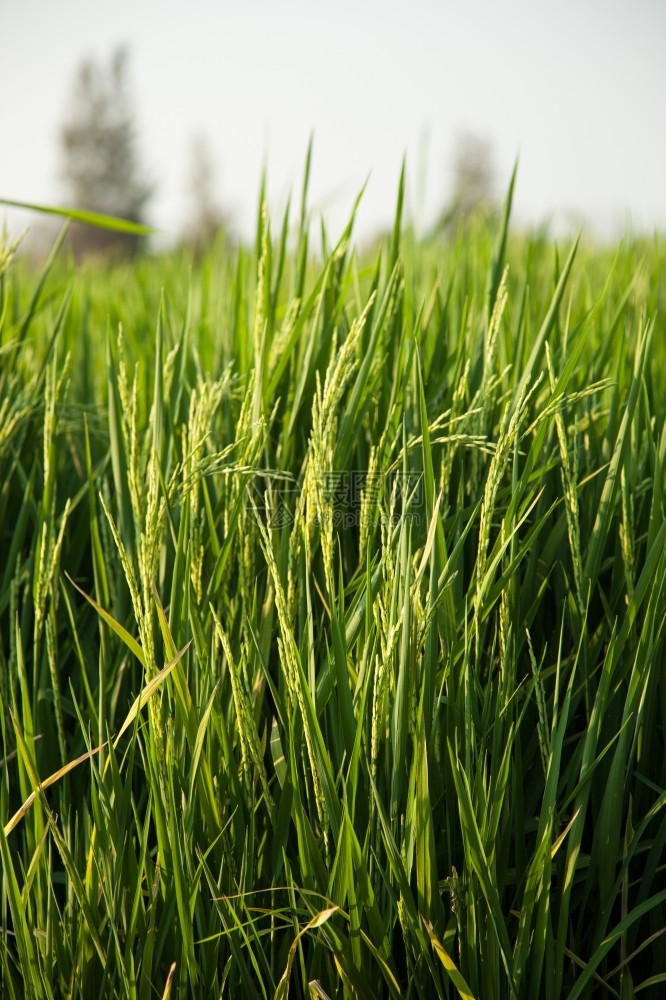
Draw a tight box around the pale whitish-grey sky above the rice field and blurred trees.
[0,0,666,248]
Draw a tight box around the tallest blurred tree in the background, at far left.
[60,47,152,253]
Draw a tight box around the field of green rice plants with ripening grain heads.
[0,168,666,1000]
